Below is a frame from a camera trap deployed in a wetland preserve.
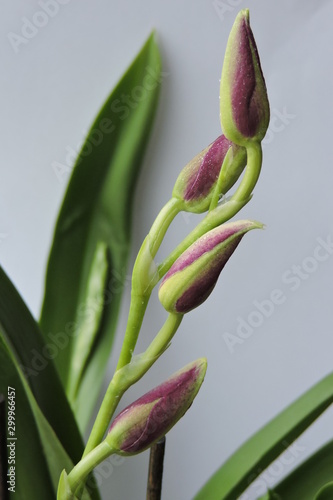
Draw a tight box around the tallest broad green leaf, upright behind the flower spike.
[40,34,161,428]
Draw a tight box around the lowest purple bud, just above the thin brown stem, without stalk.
[106,358,207,455]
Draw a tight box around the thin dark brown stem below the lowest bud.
[147,436,165,500]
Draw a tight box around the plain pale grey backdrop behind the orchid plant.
[0,0,333,500]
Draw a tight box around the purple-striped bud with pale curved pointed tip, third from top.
[158,220,263,314]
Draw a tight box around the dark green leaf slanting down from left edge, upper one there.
[0,267,83,463]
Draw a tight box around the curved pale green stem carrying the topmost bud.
[158,142,262,279]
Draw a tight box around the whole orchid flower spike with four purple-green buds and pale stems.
[58,10,269,498]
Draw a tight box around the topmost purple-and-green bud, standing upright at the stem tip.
[220,9,269,146]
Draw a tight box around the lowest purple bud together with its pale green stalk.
[63,358,207,500]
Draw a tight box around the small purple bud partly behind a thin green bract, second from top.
[172,135,246,213]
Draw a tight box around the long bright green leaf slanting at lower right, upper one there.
[195,373,333,500]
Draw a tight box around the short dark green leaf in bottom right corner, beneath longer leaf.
[260,441,333,500]
